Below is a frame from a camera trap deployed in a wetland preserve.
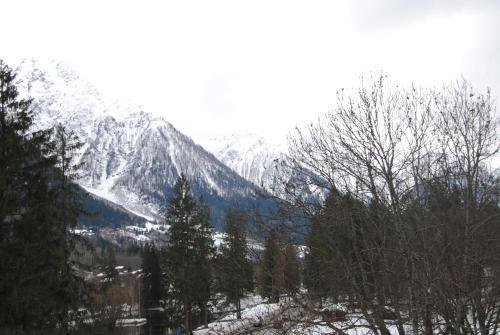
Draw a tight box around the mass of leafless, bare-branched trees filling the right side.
[287,76,500,335]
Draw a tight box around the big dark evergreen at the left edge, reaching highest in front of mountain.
[0,61,83,333]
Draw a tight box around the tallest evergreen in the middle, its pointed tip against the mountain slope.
[166,174,213,334]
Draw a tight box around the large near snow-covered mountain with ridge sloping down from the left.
[17,60,266,228]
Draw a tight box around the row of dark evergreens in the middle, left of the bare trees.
[137,175,301,334]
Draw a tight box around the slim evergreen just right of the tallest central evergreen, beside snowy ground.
[219,207,253,319]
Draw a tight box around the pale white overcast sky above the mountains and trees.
[0,0,500,144]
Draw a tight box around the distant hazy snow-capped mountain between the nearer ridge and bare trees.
[205,133,285,193]
